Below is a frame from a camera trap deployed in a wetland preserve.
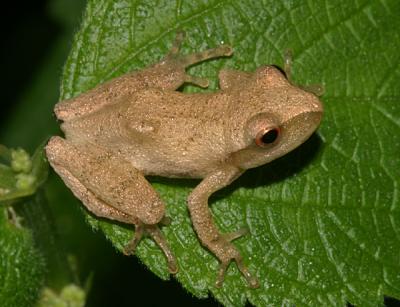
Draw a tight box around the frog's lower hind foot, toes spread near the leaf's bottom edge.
[123,218,178,274]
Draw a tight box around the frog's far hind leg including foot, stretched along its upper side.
[54,32,232,121]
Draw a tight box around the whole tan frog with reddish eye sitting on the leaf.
[46,33,323,287]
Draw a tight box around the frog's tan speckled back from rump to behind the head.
[62,89,231,178]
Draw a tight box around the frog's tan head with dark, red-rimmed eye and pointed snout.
[231,66,323,169]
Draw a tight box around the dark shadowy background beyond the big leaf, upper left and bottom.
[0,0,398,306]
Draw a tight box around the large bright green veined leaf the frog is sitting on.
[57,0,400,306]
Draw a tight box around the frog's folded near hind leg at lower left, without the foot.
[46,137,165,225]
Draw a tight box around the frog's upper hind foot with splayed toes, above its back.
[166,31,233,88]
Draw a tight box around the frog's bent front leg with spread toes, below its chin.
[188,166,258,288]
